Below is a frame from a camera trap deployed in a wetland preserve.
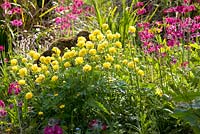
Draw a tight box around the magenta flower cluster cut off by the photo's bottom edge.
[44,125,63,134]
